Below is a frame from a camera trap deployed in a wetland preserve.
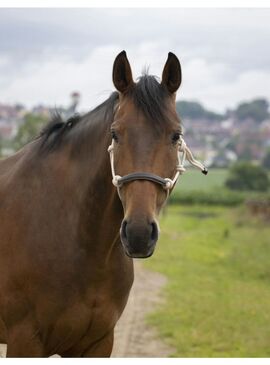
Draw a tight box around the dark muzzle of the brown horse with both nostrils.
[120,220,159,258]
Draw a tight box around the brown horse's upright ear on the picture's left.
[113,51,134,93]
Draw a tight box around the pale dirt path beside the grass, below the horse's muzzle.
[0,261,173,357]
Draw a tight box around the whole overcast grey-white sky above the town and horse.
[0,8,270,111]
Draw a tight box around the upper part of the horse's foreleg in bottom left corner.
[7,321,45,357]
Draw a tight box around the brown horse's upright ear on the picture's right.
[161,52,182,94]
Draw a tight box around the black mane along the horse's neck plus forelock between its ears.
[38,73,169,152]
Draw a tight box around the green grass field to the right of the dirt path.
[145,206,270,357]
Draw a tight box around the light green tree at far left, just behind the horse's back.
[13,113,47,149]
